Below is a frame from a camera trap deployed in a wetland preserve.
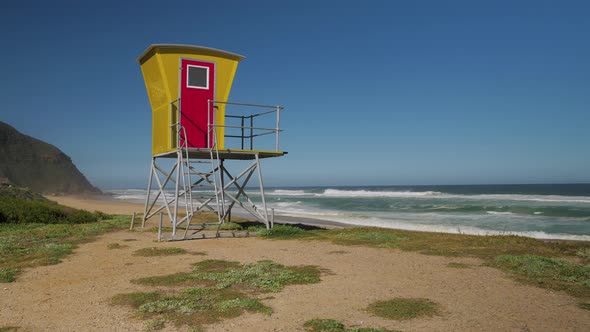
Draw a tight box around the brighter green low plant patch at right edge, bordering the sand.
[493,255,590,297]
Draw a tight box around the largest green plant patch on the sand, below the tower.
[113,260,320,328]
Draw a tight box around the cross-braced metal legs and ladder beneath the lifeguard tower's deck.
[142,151,272,240]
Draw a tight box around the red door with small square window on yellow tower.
[180,59,215,148]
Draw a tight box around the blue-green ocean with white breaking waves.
[109,184,590,241]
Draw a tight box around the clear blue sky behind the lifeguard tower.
[0,0,590,189]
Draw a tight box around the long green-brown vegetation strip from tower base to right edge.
[259,225,590,298]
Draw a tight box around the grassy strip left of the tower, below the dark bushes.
[0,216,129,282]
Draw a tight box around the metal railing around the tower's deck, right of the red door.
[207,100,284,152]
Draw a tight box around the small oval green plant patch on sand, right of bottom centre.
[367,298,440,320]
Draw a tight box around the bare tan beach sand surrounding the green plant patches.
[0,196,590,331]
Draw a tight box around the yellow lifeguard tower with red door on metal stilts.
[137,44,286,240]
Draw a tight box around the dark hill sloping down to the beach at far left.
[0,121,100,194]
